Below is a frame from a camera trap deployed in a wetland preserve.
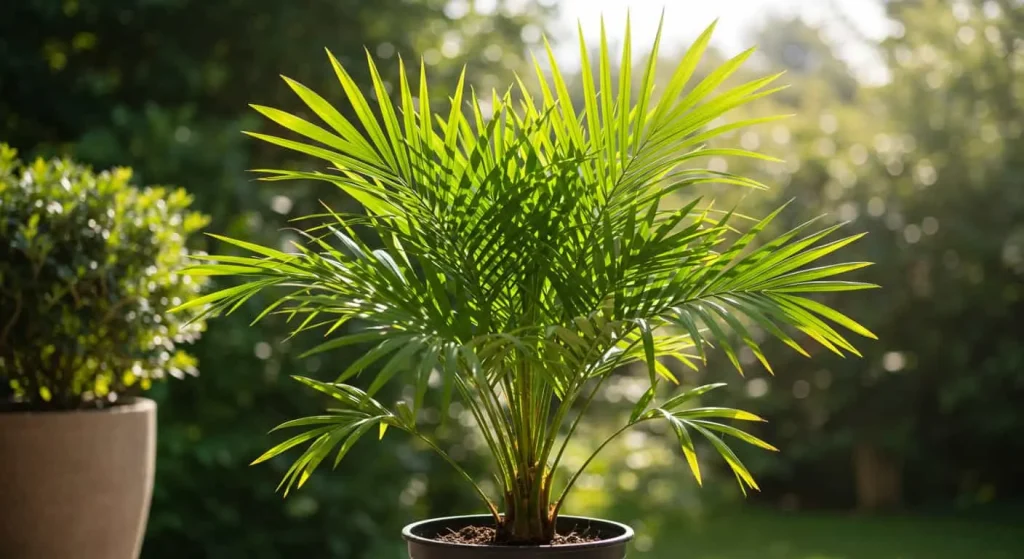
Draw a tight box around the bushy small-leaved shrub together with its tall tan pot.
[0,143,207,559]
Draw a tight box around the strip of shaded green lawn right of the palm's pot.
[630,503,1024,559]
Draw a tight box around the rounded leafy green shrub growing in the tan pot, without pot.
[0,144,207,409]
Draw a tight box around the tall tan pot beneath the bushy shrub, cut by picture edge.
[0,398,157,559]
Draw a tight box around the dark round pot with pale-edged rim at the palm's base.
[401,515,633,559]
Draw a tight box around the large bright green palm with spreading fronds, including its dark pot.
[185,19,871,559]
